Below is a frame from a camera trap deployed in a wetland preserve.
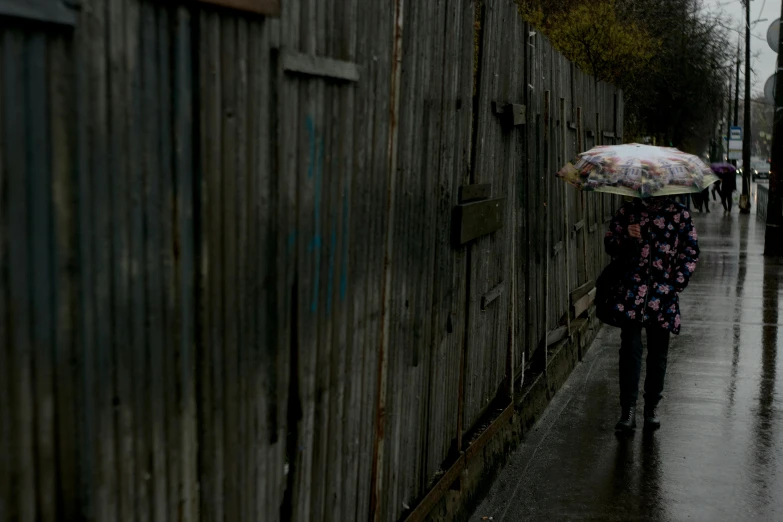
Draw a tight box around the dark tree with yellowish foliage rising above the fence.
[518,0,734,154]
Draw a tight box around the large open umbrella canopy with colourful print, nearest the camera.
[557,143,718,198]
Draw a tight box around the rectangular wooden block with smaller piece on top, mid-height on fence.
[453,184,506,246]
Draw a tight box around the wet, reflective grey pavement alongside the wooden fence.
[471,191,783,521]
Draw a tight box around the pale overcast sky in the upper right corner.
[704,0,781,93]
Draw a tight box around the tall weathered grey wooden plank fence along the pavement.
[0,0,623,522]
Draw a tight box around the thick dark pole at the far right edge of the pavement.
[764,10,783,256]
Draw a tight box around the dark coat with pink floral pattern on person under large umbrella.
[604,199,699,334]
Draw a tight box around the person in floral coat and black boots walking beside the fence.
[604,198,699,433]
